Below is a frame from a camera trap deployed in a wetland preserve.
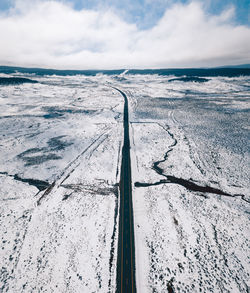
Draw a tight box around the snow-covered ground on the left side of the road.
[0,77,123,292]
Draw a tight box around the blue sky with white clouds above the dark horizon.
[0,0,250,69]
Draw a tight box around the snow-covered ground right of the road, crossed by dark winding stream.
[124,76,250,292]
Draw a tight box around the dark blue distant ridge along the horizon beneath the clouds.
[0,64,250,77]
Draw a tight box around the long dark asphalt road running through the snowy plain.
[114,88,136,293]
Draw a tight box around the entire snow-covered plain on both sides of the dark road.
[0,74,250,293]
